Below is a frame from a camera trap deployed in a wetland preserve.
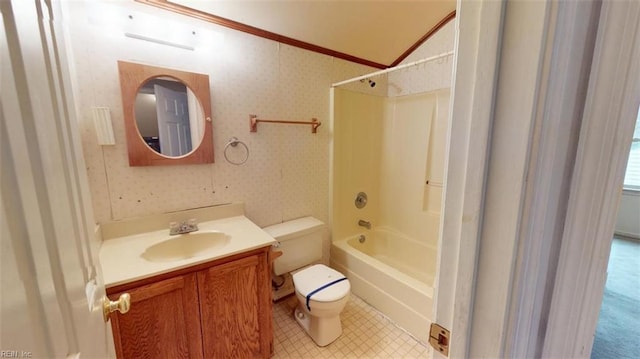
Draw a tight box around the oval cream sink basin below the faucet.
[141,231,230,262]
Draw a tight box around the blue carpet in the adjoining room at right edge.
[591,237,640,359]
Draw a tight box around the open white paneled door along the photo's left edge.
[0,0,110,358]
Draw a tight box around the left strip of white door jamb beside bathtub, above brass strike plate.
[436,0,504,358]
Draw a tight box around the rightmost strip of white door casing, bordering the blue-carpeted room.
[542,1,640,357]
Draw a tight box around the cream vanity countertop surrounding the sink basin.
[100,216,276,288]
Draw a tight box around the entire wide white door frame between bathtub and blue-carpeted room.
[434,1,640,358]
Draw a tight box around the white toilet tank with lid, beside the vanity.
[263,217,325,275]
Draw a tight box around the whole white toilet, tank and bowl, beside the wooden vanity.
[263,217,351,347]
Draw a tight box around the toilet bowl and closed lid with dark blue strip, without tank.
[293,264,351,346]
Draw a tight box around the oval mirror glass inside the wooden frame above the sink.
[135,77,205,157]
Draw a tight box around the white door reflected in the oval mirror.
[153,85,191,157]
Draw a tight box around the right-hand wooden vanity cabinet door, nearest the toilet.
[198,253,273,358]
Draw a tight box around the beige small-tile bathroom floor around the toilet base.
[273,294,430,359]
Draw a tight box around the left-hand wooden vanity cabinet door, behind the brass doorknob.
[110,273,202,359]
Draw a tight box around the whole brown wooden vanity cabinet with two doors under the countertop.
[107,247,273,358]
